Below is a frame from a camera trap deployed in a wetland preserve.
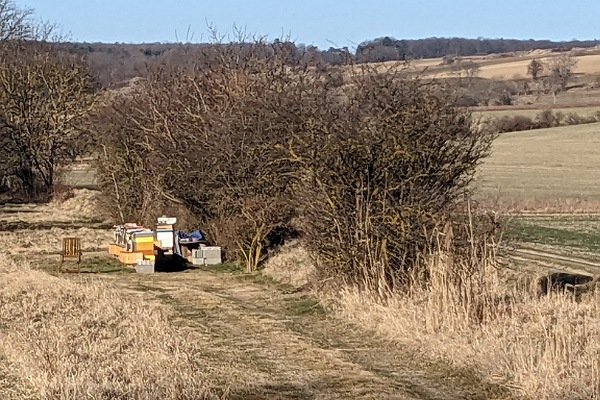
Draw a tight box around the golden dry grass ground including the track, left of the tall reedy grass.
[0,190,506,400]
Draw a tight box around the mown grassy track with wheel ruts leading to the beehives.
[93,270,506,399]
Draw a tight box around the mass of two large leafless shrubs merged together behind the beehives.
[98,47,492,287]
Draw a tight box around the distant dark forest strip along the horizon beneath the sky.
[64,37,600,87]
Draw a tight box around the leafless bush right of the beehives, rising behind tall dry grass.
[290,69,493,293]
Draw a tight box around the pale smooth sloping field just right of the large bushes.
[476,123,600,211]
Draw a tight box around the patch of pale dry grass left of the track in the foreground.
[0,260,219,400]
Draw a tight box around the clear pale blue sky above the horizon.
[15,0,600,48]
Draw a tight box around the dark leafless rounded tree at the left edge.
[0,42,94,196]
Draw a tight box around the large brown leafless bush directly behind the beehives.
[98,45,310,270]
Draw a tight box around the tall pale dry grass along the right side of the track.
[330,248,600,399]
